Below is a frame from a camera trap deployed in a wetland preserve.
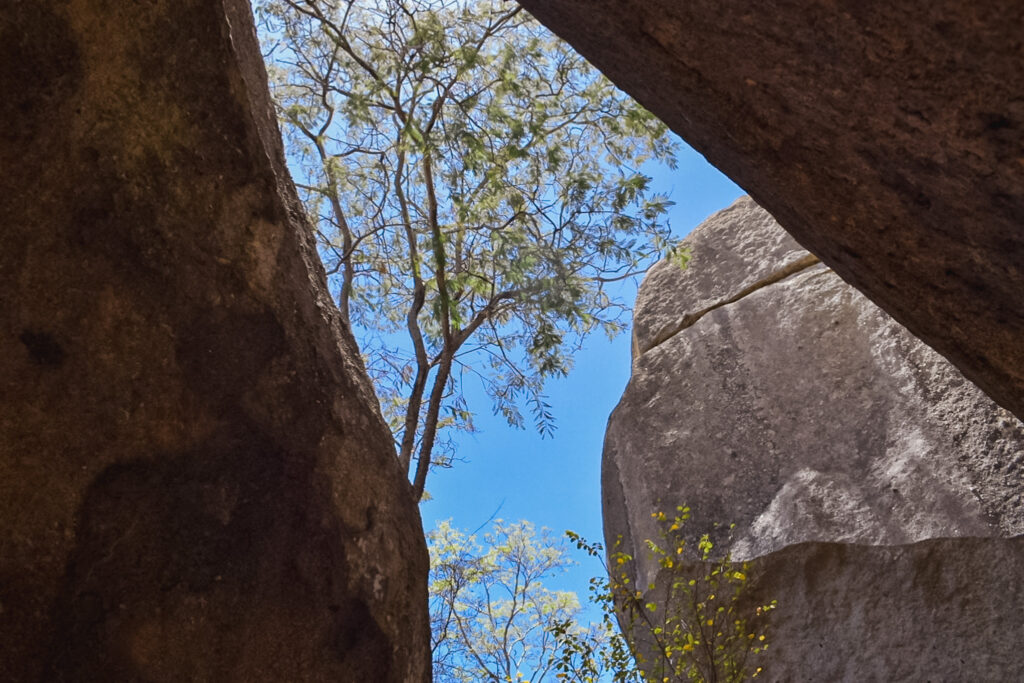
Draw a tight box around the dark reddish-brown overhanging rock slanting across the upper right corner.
[522,0,1024,418]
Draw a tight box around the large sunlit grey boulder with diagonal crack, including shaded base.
[602,198,1024,680]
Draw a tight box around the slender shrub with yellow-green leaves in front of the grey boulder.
[556,506,777,683]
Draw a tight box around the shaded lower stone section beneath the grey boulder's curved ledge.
[751,537,1024,683]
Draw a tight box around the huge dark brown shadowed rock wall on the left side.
[0,0,430,682]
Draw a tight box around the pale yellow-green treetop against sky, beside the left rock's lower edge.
[427,520,597,683]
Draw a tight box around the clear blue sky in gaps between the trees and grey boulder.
[420,136,743,600]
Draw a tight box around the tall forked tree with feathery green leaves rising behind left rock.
[257,0,675,499]
